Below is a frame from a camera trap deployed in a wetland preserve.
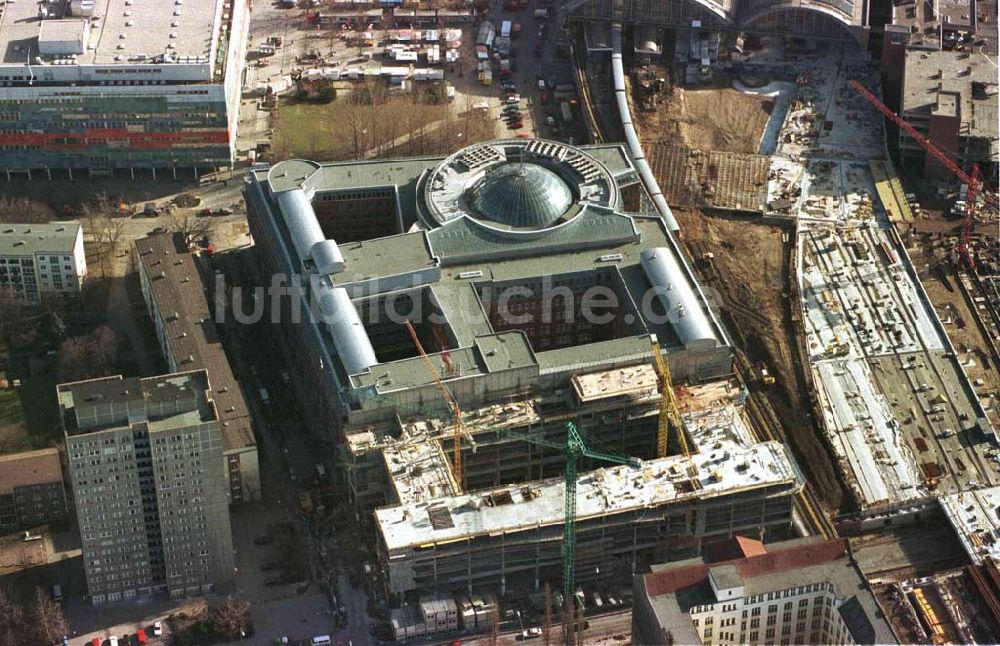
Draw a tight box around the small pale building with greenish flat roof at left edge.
[0,222,87,303]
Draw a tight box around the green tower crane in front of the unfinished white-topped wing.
[496,422,642,636]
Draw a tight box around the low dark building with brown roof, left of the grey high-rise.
[0,448,66,534]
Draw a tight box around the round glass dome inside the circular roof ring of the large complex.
[472,163,573,229]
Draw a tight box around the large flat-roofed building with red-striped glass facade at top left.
[0,0,250,175]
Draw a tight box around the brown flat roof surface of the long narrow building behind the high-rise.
[135,234,256,451]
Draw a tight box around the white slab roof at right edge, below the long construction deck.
[938,487,1000,564]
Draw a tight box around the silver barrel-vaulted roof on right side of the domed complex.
[639,247,717,348]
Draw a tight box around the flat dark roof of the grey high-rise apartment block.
[56,370,218,436]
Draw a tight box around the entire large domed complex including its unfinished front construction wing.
[246,139,799,592]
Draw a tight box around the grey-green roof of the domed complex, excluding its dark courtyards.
[249,139,728,409]
